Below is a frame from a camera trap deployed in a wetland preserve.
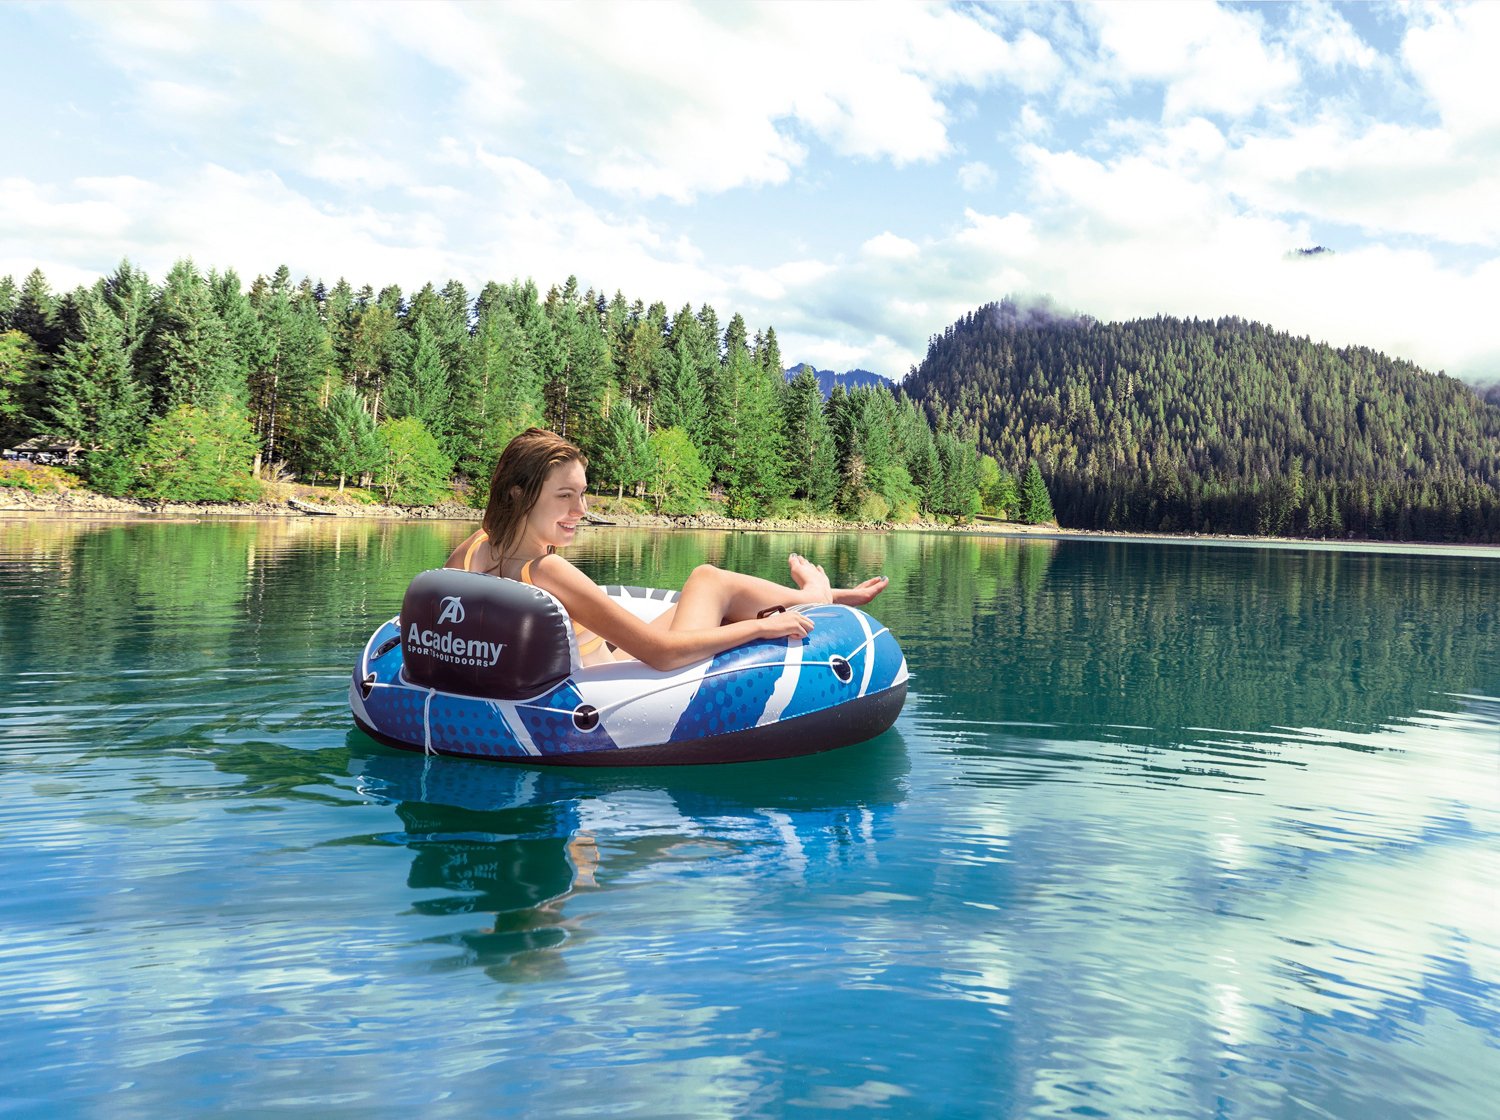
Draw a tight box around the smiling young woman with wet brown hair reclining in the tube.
[447,427,887,670]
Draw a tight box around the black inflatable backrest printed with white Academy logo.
[401,568,579,700]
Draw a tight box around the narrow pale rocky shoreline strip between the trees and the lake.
[0,487,1500,559]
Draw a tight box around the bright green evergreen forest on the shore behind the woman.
[0,261,1026,522]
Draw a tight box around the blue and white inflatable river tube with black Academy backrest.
[350,568,908,766]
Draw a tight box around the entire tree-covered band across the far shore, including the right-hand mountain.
[0,261,1500,543]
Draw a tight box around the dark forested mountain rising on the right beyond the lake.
[902,301,1500,541]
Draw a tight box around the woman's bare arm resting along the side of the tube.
[531,555,813,672]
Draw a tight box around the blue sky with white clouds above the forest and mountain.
[0,0,1500,382]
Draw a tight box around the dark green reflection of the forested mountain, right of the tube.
[882,541,1500,780]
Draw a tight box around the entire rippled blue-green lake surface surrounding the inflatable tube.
[0,519,1500,1120]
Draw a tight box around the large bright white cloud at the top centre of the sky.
[349,3,1059,202]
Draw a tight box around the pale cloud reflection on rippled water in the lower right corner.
[936,697,1500,1117]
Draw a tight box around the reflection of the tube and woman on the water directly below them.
[350,732,909,982]
